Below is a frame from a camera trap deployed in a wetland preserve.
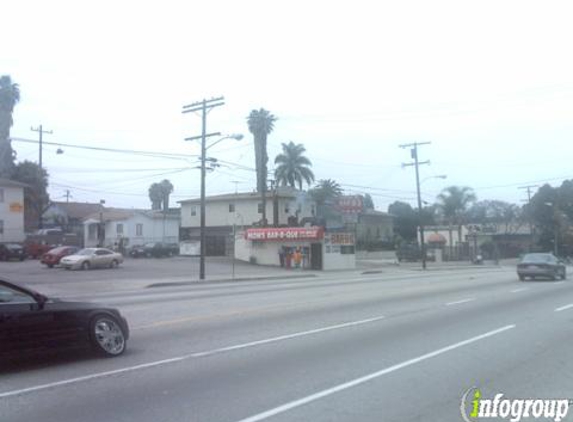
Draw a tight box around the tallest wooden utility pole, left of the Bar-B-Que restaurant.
[183,97,225,280]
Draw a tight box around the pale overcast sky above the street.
[0,0,573,210]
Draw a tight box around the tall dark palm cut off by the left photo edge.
[0,75,20,178]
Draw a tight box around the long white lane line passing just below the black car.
[0,316,384,399]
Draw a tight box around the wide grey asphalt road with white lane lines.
[0,268,573,422]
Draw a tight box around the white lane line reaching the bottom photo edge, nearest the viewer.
[230,325,515,422]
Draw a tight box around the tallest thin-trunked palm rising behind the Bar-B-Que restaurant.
[247,108,277,225]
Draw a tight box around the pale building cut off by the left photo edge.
[0,179,26,242]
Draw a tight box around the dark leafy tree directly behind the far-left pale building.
[12,161,50,231]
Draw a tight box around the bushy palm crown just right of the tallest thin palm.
[275,141,314,190]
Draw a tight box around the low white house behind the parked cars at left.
[84,208,180,247]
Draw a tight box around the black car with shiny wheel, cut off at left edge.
[0,280,129,358]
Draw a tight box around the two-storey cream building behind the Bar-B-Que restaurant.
[180,187,316,255]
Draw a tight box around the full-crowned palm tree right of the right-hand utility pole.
[438,186,477,245]
